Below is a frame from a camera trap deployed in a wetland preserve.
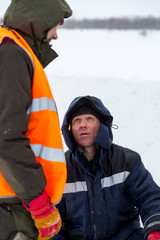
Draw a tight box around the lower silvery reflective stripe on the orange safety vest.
[30,144,66,163]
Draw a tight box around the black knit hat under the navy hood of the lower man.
[68,103,103,123]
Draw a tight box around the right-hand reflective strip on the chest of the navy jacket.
[101,171,130,188]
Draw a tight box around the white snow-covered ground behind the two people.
[45,29,160,185]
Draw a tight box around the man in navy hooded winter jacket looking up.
[54,96,160,240]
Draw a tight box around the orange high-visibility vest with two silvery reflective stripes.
[0,27,67,203]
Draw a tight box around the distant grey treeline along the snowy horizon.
[63,17,160,30]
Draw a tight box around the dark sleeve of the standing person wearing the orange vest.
[0,42,46,205]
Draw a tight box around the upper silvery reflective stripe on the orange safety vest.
[27,97,57,115]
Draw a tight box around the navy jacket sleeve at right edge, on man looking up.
[126,154,160,239]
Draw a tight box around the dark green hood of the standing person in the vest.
[3,0,72,65]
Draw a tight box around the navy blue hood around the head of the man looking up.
[62,96,113,152]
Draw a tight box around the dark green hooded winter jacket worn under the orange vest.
[0,0,72,206]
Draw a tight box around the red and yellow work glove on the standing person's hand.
[22,191,61,240]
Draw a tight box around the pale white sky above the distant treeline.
[0,0,160,19]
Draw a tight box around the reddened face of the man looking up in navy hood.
[72,114,100,147]
